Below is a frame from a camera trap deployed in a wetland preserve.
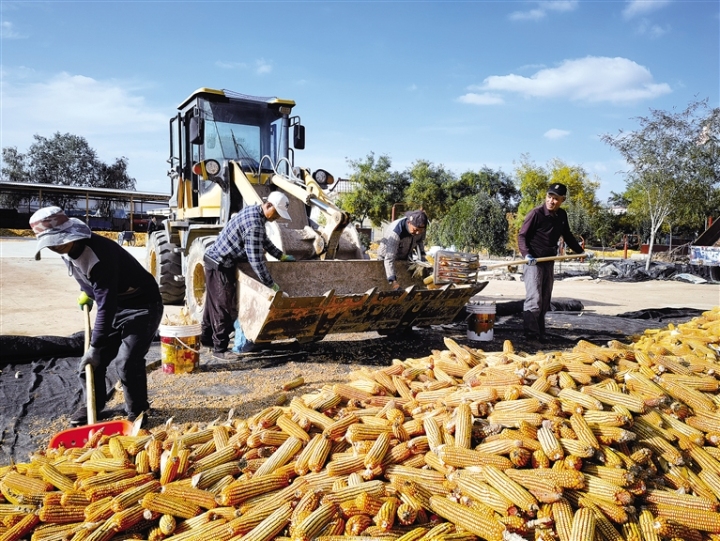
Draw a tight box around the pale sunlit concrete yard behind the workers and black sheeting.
[0,238,720,336]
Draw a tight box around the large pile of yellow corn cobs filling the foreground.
[0,308,720,541]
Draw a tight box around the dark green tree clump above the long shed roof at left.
[2,132,135,210]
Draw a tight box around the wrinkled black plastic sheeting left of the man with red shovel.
[0,332,152,465]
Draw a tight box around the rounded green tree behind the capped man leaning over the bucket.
[405,160,457,220]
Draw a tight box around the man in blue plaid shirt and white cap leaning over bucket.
[201,191,295,361]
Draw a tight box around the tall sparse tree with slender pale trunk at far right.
[601,99,720,269]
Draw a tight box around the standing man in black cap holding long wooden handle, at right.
[518,183,583,343]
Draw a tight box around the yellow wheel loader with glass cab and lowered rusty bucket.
[147,88,487,343]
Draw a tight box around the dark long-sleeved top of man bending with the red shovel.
[63,233,162,347]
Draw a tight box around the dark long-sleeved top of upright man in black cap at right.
[518,204,583,257]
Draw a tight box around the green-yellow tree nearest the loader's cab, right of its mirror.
[338,152,409,227]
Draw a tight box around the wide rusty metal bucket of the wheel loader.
[238,260,487,343]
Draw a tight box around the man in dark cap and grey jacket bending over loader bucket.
[377,210,428,289]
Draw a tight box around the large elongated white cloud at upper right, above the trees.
[480,56,672,103]
